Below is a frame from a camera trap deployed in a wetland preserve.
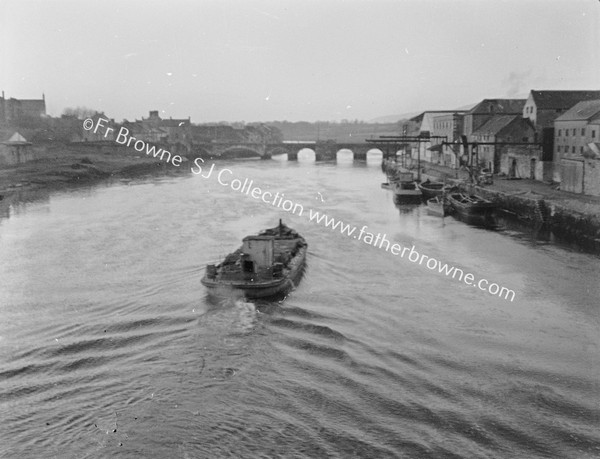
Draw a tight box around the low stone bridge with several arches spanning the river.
[188,140,395,161]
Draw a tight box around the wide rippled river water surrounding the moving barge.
[0,156,600,458]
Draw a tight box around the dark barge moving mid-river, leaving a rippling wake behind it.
[201,220,308,298]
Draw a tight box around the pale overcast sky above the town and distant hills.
[0,0,600,122]
